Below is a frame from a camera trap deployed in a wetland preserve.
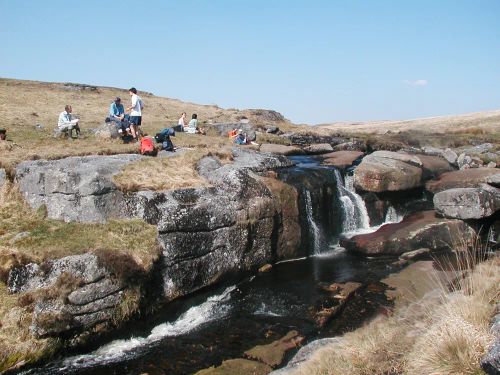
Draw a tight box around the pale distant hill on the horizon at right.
[315,110,500,134]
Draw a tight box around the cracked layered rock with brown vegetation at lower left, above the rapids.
[8,253,126,337]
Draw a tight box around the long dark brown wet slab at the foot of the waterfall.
[340,211,474,255]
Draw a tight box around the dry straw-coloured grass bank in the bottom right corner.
[291,247,500,375]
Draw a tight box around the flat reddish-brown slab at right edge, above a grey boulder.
[425,168,500,194]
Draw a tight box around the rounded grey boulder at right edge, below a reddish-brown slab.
[434,184,500,219]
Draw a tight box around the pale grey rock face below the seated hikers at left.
[16,155,141,222]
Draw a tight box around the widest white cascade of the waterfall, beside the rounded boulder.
[334,169,370,233]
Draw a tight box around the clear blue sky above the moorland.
[0,0,500,124]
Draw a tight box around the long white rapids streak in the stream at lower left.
[55,286,236,370]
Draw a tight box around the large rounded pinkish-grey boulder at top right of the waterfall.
[354,151,422,193]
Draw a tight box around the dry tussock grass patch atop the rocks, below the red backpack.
[113,148,232,191]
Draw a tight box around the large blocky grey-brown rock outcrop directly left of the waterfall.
[129,149,300,300]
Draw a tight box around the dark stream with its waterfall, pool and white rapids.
[18,158,401,375]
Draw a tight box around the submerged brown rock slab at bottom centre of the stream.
[245,331,304,367]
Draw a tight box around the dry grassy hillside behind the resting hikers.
[0,78,292,171]
